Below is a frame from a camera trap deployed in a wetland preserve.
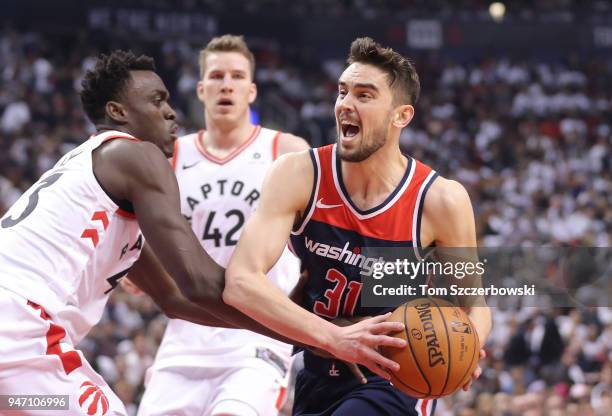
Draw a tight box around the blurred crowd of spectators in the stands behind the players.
[0,19,612,416]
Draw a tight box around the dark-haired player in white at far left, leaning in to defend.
[0,51,406,415]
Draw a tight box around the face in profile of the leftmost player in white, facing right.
[122,71,178,157]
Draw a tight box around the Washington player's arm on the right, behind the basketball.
[422,177,492,390]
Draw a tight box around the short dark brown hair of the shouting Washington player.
[346,37,421,105]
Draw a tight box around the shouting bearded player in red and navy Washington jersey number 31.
[223,38,491,416]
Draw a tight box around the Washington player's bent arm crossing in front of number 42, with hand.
[223,152,405,379]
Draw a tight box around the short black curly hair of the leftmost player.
[81,49,155,123]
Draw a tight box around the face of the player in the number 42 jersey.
[198,52,257,124]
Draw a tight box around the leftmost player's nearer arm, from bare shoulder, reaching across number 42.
[93,140,300,340]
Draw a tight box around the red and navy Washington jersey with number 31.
[291,145,437,319]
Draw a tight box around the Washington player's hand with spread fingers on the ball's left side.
[329,313,406,380]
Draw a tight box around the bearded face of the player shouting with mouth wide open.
[335,63,393,162]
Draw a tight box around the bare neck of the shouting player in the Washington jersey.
[340,147,408,210]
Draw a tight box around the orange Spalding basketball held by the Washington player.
[381,298,480,399]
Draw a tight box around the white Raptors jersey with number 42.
[155,126,299,368]
